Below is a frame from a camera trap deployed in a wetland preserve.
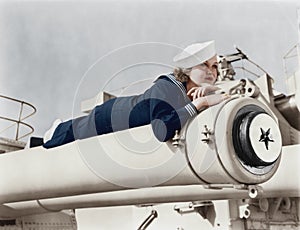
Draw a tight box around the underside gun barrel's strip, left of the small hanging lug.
[0,185,248,218]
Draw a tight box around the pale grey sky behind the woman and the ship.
[0,0,300,228]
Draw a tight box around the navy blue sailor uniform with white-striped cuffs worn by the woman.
[44,74,197,148]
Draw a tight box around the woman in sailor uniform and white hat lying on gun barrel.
[44,41,228,148]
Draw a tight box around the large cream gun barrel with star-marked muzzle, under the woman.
[0,97,282,204]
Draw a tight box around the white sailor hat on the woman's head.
[173,41,216,68]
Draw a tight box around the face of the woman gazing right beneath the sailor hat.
[190,55,218,86]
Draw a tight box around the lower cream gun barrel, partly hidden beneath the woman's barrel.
[0,145,300,219]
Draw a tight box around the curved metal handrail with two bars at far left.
[0,95,37,141]
